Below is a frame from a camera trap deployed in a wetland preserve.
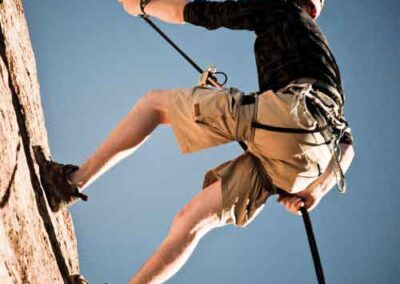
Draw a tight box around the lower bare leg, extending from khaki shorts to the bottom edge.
[130,181,226,284]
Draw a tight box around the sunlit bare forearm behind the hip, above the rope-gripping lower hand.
[319,144,354,195]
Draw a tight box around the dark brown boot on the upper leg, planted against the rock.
[33,146,88,212]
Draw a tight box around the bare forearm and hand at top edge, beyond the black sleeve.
[120,0,187,24]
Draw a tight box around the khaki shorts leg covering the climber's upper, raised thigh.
[169,87,255,153]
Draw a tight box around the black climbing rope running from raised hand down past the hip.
[141,10,325,284]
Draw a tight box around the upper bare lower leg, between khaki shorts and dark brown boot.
[71,90,171,189]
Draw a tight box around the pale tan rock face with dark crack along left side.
[0,0,79,284]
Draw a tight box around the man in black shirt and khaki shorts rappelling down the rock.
[36,0,354,283]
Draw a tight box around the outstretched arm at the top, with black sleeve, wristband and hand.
[119,0,265,30]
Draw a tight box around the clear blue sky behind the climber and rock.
[24,0,400,284]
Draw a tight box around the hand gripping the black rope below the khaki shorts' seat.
[277,175,326,216]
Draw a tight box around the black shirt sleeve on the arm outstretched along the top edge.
[183,0,265,30]
